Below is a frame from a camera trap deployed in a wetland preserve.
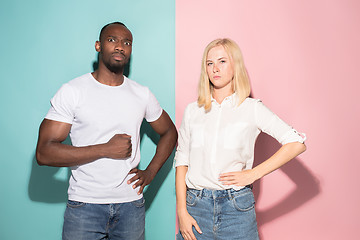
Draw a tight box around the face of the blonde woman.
[206,45,234,91]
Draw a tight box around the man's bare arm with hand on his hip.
[128,111,177,194]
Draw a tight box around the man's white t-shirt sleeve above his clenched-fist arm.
[45,83,77,124]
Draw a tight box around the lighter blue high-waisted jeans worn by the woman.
[176,187,259,240]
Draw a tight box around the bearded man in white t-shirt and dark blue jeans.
[36,22,177,240]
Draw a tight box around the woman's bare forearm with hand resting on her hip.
[219,142,306,186]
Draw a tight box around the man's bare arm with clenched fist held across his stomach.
[36,119,131,167]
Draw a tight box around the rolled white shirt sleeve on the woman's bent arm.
[255,100,306,145]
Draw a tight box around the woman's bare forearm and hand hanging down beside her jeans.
[175,166,202,240]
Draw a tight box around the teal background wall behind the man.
[0,0,175,240]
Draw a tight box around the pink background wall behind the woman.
[176,0,360,240]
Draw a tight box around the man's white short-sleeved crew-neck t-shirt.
[45,73,162,204]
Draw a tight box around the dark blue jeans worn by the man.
[62,198,145,240]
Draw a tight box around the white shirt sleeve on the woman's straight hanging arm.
[174,106,190,167]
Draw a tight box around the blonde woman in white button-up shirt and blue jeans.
[175,39,306,240]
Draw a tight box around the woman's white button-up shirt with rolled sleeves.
[175,94,305,190]
